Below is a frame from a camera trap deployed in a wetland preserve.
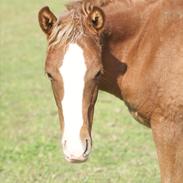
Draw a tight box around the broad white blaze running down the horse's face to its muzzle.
[59,44,86,156]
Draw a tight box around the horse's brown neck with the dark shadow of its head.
[100,0,158,99]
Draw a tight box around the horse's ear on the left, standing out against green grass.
[38,6,57,36]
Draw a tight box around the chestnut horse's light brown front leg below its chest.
[151,119,183,183]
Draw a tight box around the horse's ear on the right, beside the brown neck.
[88,6,105,32]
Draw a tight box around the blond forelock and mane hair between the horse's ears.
[48,0,112,47]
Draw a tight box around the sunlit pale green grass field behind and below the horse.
[0,0,160,183]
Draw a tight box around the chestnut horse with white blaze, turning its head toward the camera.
[38,0,183,183]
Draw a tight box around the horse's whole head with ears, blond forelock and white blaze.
[39,3,104,162]
